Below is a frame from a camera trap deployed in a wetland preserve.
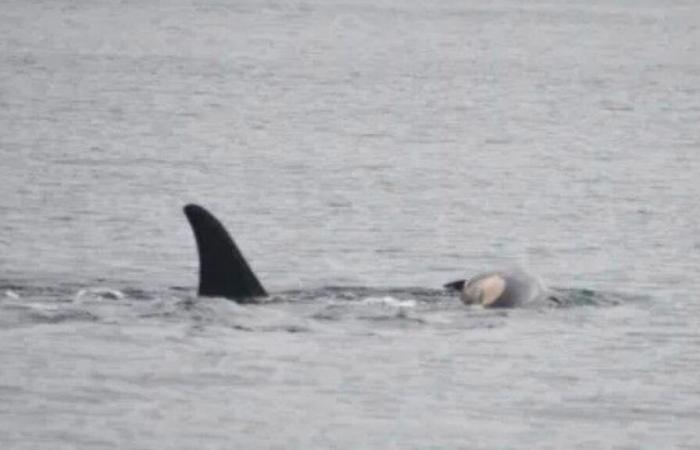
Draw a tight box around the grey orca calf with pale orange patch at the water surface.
[444,270,561,308]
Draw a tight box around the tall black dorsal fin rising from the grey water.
[184,204,267,301]
